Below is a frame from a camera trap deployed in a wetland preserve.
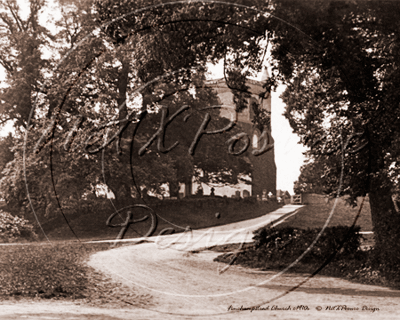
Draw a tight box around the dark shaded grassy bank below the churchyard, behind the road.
[38,198,281,240]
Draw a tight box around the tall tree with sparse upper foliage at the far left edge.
[0,0,59,216]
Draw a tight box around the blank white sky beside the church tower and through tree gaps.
[0,0,306,194]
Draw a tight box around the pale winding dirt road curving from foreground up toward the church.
[0,208,400,320]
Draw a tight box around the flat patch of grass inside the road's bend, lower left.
[0,242,150,307]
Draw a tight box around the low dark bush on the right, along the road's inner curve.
[214,227,400,289]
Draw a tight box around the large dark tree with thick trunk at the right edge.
[270,0,400,271]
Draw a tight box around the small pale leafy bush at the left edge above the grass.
[0,210,37,242]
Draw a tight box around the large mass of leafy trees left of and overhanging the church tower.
[1,0,265,222]
